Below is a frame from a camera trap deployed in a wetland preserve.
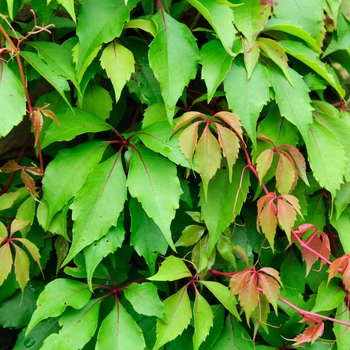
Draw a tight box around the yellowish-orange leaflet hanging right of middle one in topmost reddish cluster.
[215,123,239,182]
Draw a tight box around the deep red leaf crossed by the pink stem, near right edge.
[302,231,330,276]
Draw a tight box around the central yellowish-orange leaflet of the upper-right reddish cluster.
[275,153,297,194]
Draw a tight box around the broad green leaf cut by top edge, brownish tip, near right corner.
[273,0,326,46]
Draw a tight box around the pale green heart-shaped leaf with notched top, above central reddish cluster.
[224,59,271,147]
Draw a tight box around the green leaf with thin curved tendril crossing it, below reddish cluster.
[199,160,250,254]
